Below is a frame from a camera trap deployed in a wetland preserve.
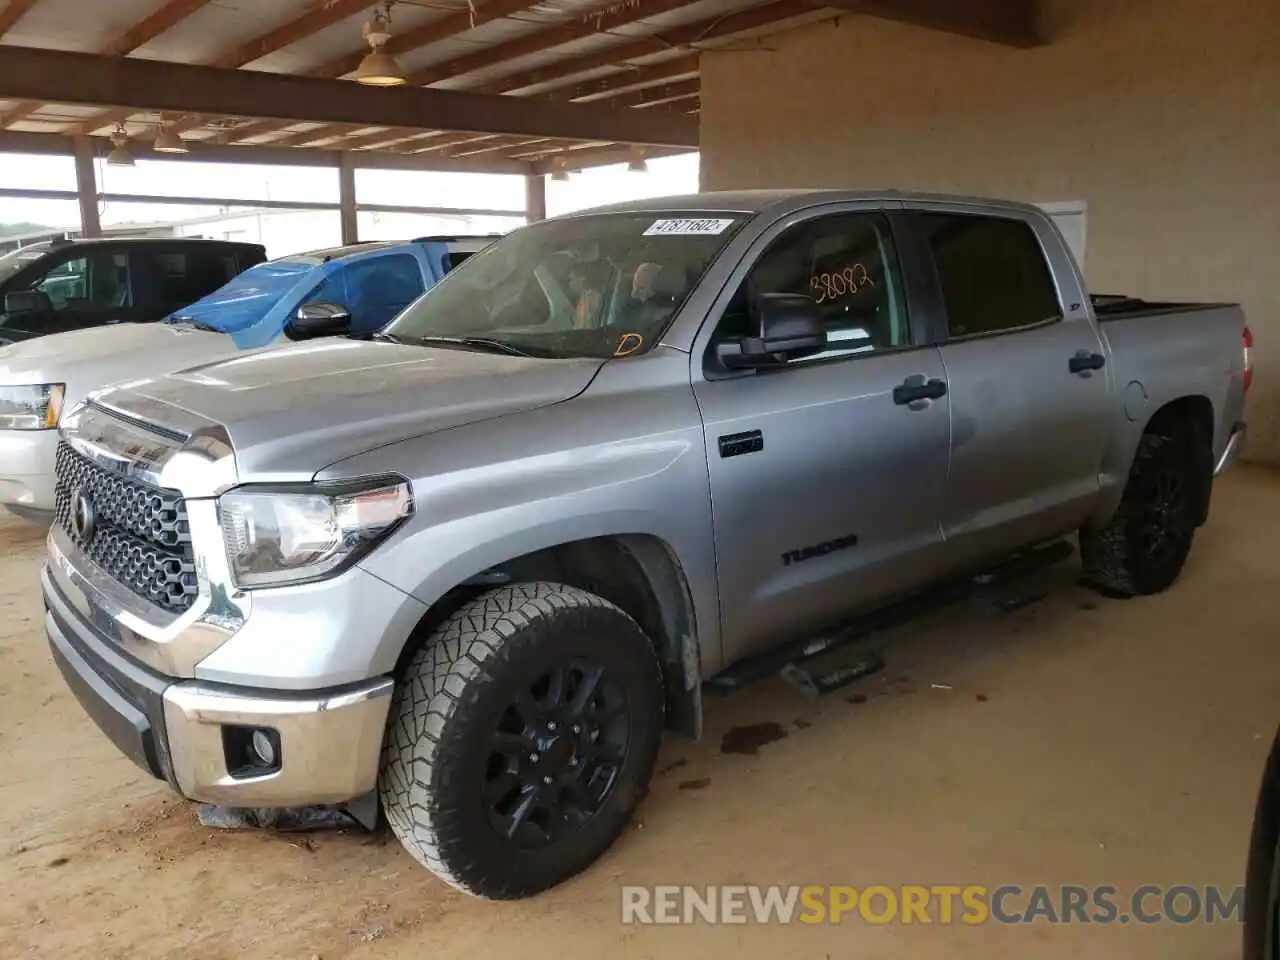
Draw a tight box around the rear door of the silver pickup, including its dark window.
[908,204,1112,562]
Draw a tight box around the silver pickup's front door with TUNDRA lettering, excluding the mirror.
[694,210,950,666]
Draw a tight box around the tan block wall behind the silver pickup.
[701,0,1280,462]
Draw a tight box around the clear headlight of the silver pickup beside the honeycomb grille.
[218,477,413,589]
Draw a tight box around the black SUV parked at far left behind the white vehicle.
[0,237,266,344]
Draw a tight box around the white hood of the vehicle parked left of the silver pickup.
[0,324,236,403]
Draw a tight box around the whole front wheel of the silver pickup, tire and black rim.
[380,582,663,899]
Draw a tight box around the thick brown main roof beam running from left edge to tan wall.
[0,45,698,147]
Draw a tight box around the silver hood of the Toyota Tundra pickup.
[94,338,604,480]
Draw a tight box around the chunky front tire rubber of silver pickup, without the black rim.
[379,582,663,900]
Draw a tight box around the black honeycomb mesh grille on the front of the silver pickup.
[54,440,198,612]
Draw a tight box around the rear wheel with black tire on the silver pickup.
[1080,431,1204,599]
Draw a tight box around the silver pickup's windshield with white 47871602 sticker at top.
[383,212,748,358]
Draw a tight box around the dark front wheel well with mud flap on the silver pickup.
[396,534,703,739]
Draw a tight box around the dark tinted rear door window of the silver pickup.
[918,212,1062,339]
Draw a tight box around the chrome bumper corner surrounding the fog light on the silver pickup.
[164,677,394,806]
